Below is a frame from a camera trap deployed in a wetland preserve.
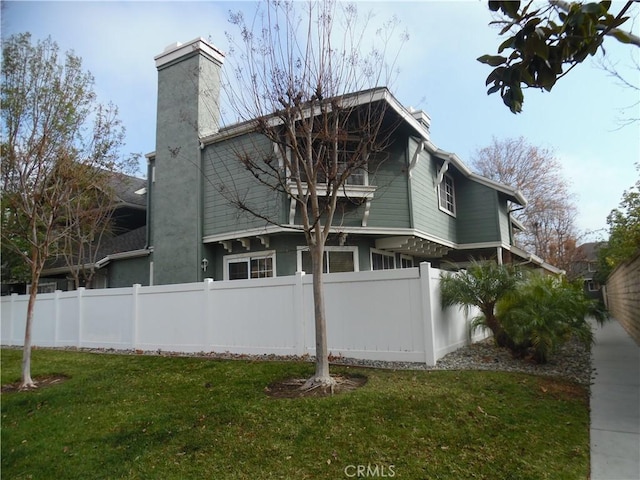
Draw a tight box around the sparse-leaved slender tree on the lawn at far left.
[2,33,131,388]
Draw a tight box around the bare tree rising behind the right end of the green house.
[472,137,578,269]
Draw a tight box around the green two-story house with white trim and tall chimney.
[141,38,556,284]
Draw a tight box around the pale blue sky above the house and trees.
[1,0,640,239]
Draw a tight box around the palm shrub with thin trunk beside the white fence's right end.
[440,261,520,347]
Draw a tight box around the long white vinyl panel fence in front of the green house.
[0,263,482,365]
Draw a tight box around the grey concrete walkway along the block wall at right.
[591,320,640,480]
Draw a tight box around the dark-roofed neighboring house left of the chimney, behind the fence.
[38,173,150,293]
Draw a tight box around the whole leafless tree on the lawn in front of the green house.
[223,1,406,389]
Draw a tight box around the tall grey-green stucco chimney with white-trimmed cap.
[150,38,224,285]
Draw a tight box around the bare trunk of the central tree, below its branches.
[302,244,335,389]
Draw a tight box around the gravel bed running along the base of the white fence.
[3,338,593,385]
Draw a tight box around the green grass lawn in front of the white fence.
[1,350,589,480]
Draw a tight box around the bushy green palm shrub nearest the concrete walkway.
[496,274,606,363]
